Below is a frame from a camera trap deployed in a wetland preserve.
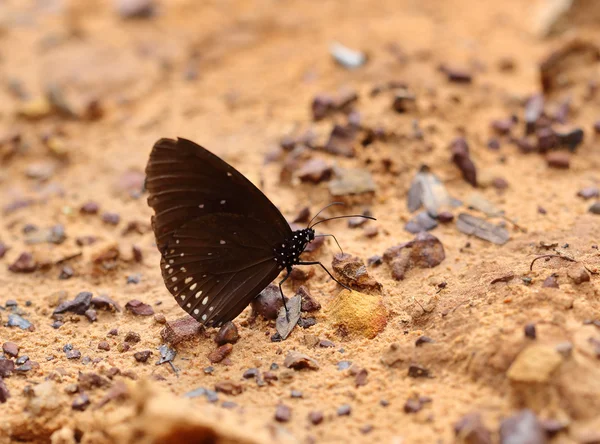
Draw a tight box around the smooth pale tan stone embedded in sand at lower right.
[506,343,562,383]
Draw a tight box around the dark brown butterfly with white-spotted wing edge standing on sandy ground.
[145,138,373,327]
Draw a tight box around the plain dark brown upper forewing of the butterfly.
[146,139,291,251]
